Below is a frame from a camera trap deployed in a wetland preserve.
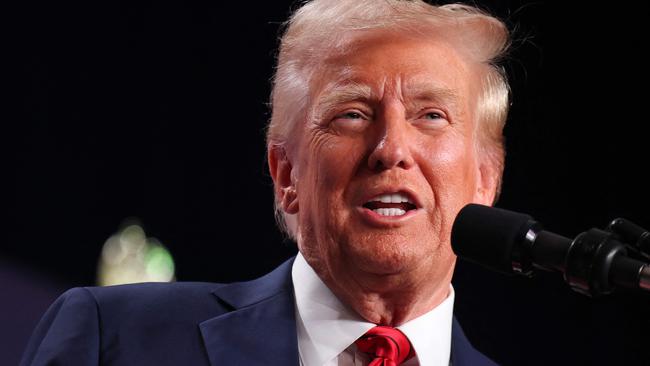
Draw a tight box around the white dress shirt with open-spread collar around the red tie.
[291,253,454,366]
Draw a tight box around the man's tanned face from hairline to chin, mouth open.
[276,36,494,294]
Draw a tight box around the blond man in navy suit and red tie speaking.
[23,0,508,366]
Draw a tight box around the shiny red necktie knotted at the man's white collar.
[354,326,413,366]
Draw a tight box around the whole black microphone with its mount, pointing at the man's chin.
[451,204,650,297]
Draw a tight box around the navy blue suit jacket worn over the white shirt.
[21,260,494,366]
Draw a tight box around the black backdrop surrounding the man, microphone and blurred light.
[5,0,650,365]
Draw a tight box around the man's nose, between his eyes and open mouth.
[368,113,414,171]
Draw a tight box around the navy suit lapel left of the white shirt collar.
[200,260,299,366]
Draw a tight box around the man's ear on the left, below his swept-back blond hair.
[267,145,298,214]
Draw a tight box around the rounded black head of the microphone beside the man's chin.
[451,204,537,273]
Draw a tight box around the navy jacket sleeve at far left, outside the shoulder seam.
[20,288,100,366]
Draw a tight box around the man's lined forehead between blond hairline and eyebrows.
[311,33,479,97]
